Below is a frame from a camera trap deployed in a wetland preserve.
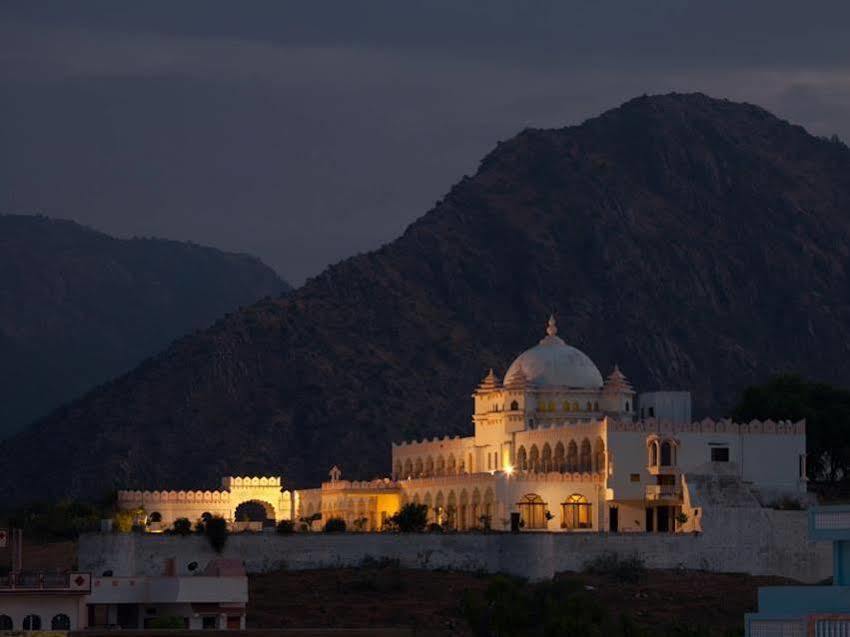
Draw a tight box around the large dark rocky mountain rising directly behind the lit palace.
[0,94,850,499]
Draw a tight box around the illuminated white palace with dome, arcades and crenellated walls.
[119,318,806,532]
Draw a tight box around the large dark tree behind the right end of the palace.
[732,374,850,484]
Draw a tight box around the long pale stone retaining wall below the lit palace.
[79,509,832,582]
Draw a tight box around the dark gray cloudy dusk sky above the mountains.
[0,0,850,284]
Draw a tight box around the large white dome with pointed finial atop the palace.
[505,318,602,389]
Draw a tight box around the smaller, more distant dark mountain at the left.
[0,215,288,437]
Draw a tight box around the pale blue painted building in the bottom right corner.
[744,506,850,637]
